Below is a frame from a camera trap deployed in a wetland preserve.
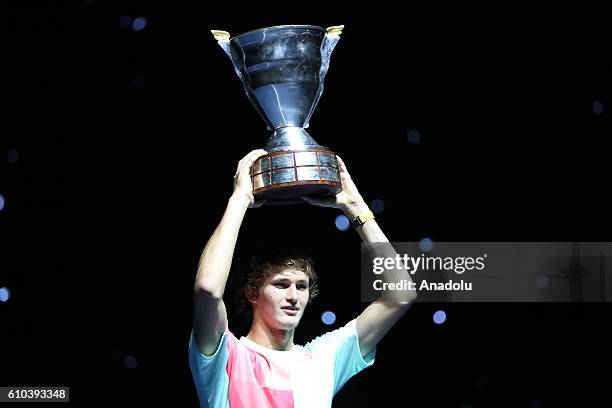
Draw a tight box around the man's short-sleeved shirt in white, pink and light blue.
[189,319,376,408]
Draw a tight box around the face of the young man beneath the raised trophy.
[254,269,310,330]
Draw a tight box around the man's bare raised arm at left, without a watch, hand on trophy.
[193,149,266,356]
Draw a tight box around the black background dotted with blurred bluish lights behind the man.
[0,0,612,407]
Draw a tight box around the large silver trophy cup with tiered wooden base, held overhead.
[211,25,344,204]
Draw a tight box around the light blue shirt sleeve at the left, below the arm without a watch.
[189,329,237,408]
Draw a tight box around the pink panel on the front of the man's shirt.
[225,331,294,408]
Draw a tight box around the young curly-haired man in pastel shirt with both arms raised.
[189,150,416,408]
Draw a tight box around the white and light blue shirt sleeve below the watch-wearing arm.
[305,319,376,395]
